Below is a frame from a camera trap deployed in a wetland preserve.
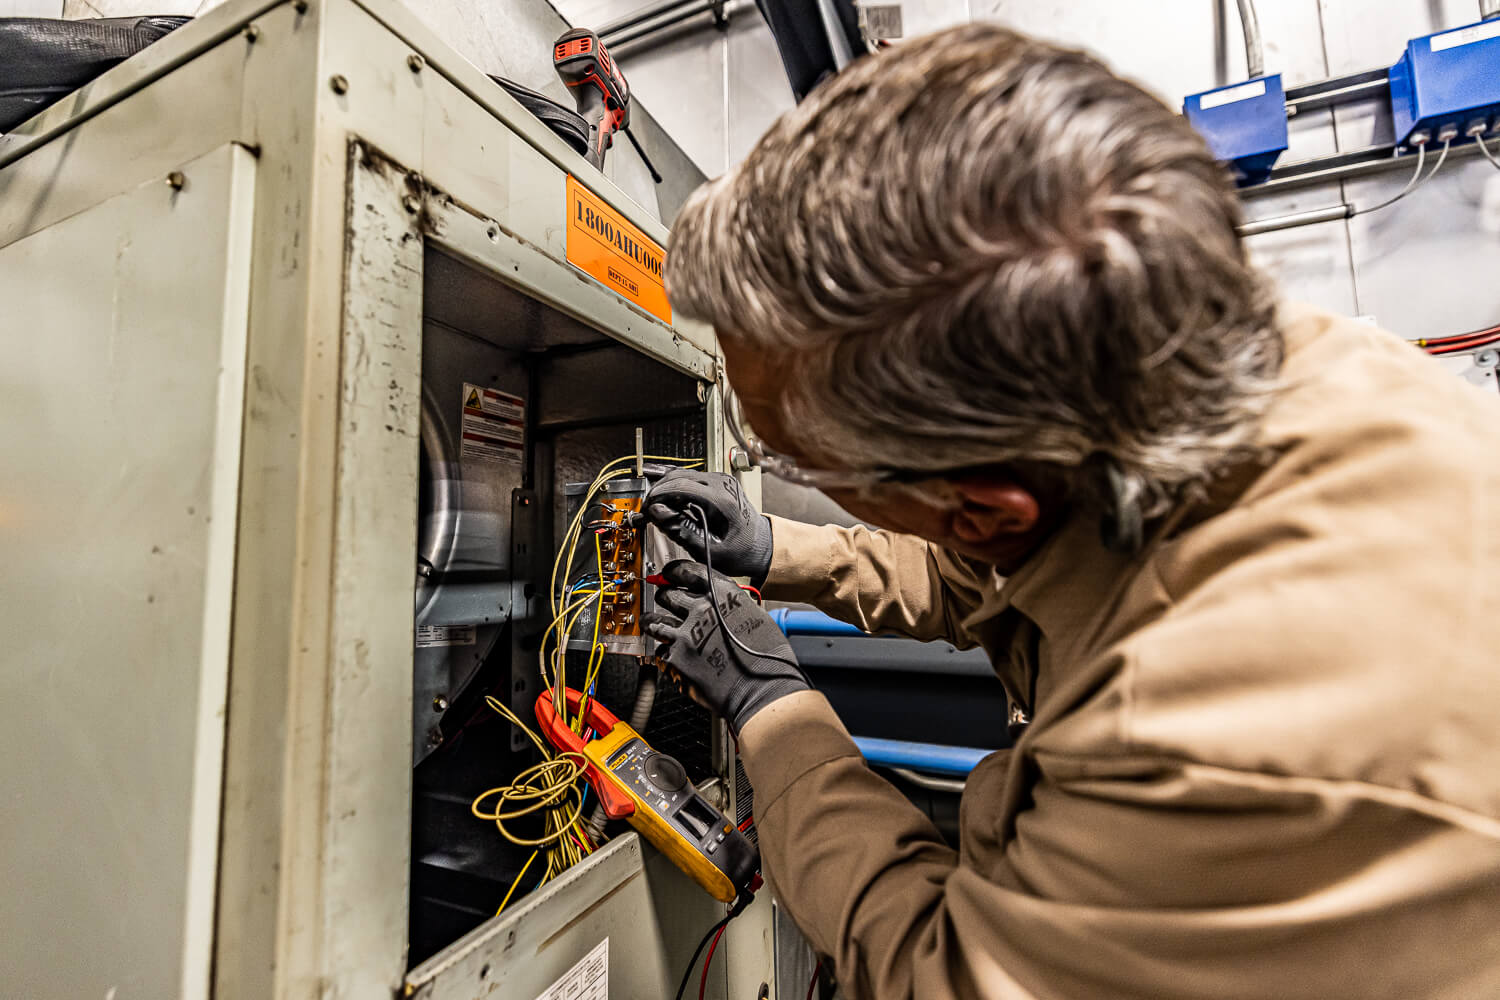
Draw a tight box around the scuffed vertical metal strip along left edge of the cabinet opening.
[321,141,422,997]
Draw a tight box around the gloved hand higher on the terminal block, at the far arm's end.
[641,469,771,589]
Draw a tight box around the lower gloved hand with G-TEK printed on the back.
[641,559,812,736]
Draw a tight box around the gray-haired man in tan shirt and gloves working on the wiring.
[648,19,1500,1000]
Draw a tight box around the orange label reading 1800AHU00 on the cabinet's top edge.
[567,174,672,322]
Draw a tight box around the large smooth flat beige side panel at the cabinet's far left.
[0,145,255,999]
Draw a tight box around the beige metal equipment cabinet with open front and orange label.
[0,0,806,1000]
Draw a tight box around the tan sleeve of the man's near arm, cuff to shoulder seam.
[741,691,1500,1000]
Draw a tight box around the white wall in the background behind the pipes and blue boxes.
[557,0,1500,336]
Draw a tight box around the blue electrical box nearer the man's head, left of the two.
[1182,73,1287,187]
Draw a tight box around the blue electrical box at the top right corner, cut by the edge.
[1391,19,1500,145]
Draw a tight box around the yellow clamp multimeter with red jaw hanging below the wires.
[537,688,761,903]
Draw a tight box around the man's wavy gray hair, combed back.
[666,24,1283,517]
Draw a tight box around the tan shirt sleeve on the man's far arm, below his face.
[762,516,986,648]
